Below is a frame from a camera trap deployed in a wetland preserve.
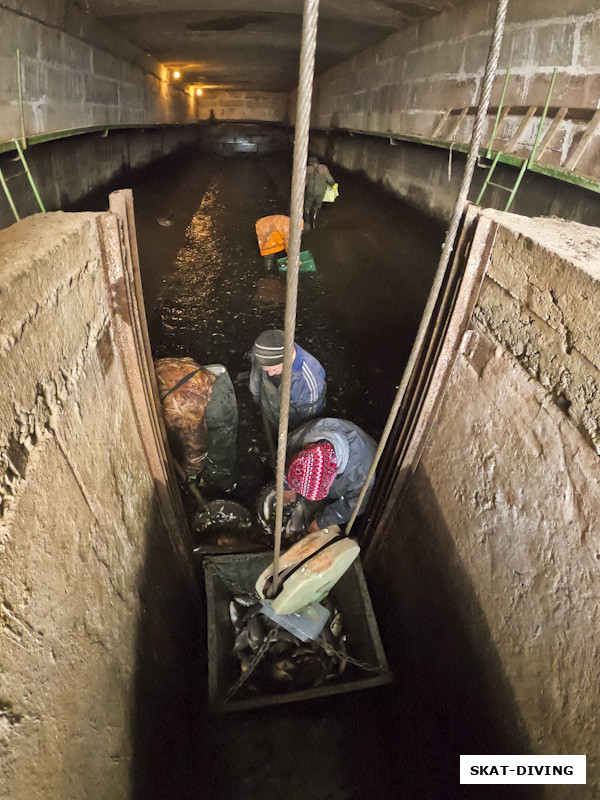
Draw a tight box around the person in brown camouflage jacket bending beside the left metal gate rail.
[154,358,238,490]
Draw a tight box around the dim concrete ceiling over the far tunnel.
[84,0,466,92]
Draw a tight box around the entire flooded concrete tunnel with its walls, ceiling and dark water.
[0,0,600,800]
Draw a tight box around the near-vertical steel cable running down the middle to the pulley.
[272,0,319,592]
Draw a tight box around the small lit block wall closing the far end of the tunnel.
[196,89,288,122]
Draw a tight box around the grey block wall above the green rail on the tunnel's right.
[312,0,600,177]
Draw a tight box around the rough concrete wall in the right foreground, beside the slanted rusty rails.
[372,212,600,800]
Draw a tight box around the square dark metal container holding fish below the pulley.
[203,553,392,713]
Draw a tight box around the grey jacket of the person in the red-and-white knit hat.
[287,417,377,528]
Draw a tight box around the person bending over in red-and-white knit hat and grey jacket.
[285,417,377,531]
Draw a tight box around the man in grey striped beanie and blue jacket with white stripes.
[250,330,327,431]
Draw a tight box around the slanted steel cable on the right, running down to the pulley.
[346,0,508,535]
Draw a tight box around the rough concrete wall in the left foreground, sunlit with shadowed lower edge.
[0,213,202,800]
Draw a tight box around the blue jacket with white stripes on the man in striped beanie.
[250,343,327,428]
